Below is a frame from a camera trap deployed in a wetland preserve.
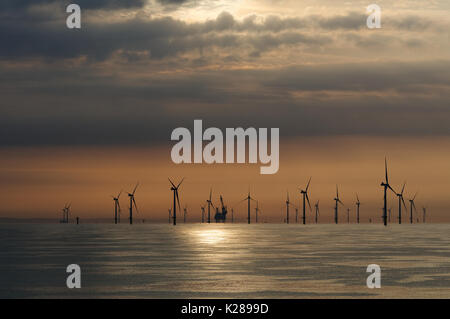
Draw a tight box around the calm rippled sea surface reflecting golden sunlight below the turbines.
[0,224,450,298]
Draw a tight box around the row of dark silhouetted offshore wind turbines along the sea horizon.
[52,158,436,226]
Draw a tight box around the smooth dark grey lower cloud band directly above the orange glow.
[0,61,450,146]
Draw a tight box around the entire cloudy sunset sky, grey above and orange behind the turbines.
[0,0,450,221]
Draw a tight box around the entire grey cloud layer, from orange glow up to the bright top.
[0,0,450,146]
